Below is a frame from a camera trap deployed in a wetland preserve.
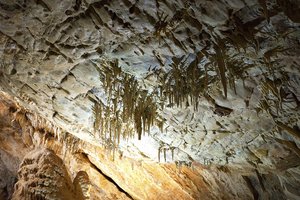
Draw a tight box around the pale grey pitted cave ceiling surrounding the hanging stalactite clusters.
[0,0,300,169]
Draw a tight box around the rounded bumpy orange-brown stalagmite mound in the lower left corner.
[12,149,88,200]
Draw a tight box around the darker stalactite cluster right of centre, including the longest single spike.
[154,38,243,110]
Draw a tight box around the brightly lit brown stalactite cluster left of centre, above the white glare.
[93,62,157,156]
